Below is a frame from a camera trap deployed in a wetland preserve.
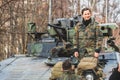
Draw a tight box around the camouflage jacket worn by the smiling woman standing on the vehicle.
[73,18,102,57]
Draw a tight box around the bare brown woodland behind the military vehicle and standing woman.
[0,0,120,60]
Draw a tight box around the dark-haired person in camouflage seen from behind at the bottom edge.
[58,59,81,80]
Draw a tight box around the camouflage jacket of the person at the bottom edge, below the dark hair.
[58,71,81,80]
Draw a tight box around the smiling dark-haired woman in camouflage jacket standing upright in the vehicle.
[73,8,102,58]
